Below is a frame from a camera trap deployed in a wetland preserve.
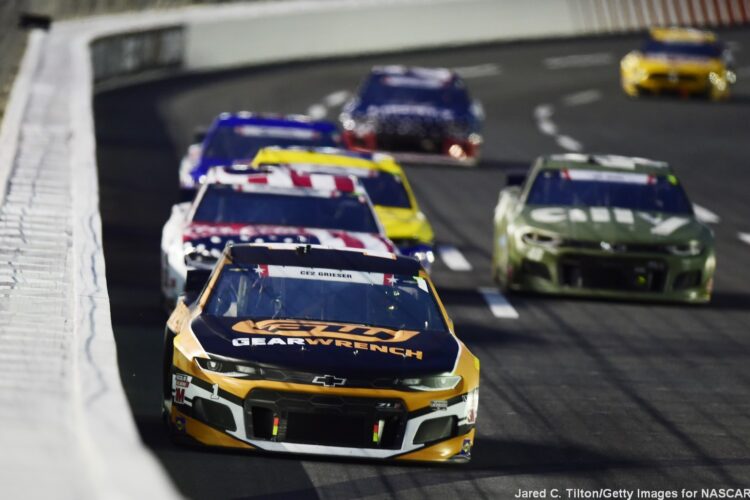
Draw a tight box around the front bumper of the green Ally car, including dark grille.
[508,247,716,303]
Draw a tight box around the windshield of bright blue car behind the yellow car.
[204,125,339,161]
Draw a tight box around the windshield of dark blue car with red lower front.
[362,75,469,110]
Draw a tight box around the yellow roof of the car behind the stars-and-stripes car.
[252,147,402,174]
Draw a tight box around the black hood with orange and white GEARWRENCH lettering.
[190,316,459,379]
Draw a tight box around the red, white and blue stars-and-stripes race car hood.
[182,223,394,252]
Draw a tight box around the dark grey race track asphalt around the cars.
[95,30,750,498]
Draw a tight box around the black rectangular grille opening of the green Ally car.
[559,255,667,292]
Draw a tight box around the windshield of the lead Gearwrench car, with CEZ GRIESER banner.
[204,264,447,332]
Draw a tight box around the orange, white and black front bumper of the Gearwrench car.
[168,369,474,461]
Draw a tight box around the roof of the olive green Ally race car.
[541,153,673,175]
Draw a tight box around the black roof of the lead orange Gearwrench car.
[224,243,422,276]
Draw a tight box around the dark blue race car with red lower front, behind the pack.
[340,66,483,163]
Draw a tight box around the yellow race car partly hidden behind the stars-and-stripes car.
[252,147,435,271]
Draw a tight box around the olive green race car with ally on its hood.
[492,154,716,302]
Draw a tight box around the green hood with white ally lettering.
[516,206,710,244]
